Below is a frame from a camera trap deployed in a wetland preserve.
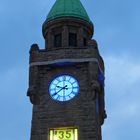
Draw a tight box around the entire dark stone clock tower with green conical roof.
[27,0,106,140]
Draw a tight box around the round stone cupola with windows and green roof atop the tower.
[42,0,94,49]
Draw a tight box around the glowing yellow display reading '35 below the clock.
[49,127,78,140]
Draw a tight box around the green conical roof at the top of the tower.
[47,0,90,22]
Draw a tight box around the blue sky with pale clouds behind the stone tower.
[0,0,140,140]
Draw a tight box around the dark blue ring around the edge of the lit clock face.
[48,73,80,102]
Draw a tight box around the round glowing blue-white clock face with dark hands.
[49,75,79,101]
